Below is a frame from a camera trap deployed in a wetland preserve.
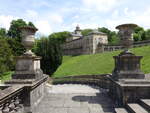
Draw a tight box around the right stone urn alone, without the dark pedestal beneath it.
[116,24,137,53]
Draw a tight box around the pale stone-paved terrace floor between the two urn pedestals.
[35,84,114,113]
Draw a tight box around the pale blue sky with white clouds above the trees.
[0,0,150,36]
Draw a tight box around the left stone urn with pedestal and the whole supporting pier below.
[5,26,48,113]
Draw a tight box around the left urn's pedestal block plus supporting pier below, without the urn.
[5,55,48,113]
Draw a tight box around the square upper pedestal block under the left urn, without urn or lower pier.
[12,56,43,79]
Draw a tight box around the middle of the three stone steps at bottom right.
[127,103,149,113]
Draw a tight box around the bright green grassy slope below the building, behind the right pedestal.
[53,46,150,77]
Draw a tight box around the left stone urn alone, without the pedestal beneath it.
[20,26,38,56]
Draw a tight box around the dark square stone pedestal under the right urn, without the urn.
[113,53,145,80]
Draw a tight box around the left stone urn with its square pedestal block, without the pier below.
[12,26,43,80]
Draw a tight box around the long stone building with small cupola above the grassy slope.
[62,26,108,55]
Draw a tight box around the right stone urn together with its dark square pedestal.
[112,24,144,80]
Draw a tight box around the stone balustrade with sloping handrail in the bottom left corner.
[0,85,23,113]
